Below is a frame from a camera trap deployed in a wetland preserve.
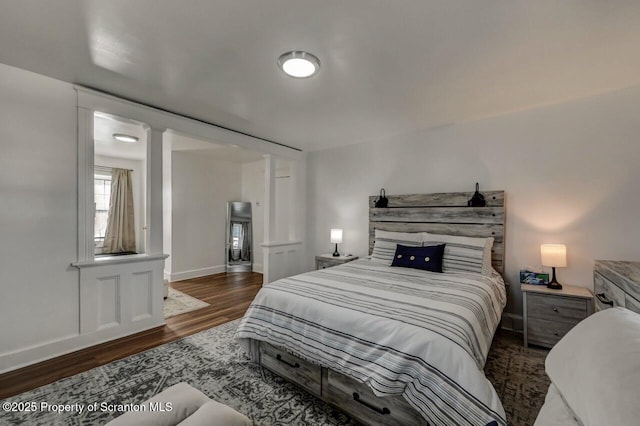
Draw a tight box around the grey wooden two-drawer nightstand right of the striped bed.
[521,284,593,348]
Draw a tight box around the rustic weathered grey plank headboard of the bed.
[369,191,505,275]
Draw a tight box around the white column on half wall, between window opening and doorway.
[145,127,165,254]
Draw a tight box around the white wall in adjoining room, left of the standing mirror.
[165,151,242,281]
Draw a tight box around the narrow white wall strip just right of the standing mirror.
[242,160,264,272]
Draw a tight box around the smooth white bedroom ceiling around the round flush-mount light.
[0,0,640,151]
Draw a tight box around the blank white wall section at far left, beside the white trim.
[0,64,80,360]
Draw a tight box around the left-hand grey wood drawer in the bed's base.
[260,342,322,396]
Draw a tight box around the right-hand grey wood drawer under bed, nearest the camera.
[322,369,427,426]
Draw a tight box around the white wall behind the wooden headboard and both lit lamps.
[307,88,640,322]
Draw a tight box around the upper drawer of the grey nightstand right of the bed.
[527,293,588,324]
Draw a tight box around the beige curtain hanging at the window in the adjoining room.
[102,169,136,253]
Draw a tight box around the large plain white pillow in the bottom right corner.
[545,308,640,426]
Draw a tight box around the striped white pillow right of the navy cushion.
[423,232,493,276]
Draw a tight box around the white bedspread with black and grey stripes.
[236,260,506,426]
